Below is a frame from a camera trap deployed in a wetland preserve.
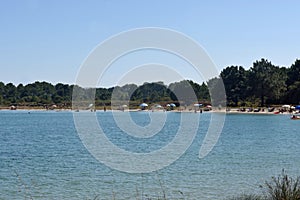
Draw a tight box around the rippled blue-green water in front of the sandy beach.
[0,111,300,199]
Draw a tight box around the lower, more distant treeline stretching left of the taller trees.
[0,81,210,108]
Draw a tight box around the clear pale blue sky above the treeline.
[0,0,300,87]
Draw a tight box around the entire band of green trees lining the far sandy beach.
[0,59,300,108]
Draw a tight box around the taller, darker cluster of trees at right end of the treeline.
[214,59,300,106]
